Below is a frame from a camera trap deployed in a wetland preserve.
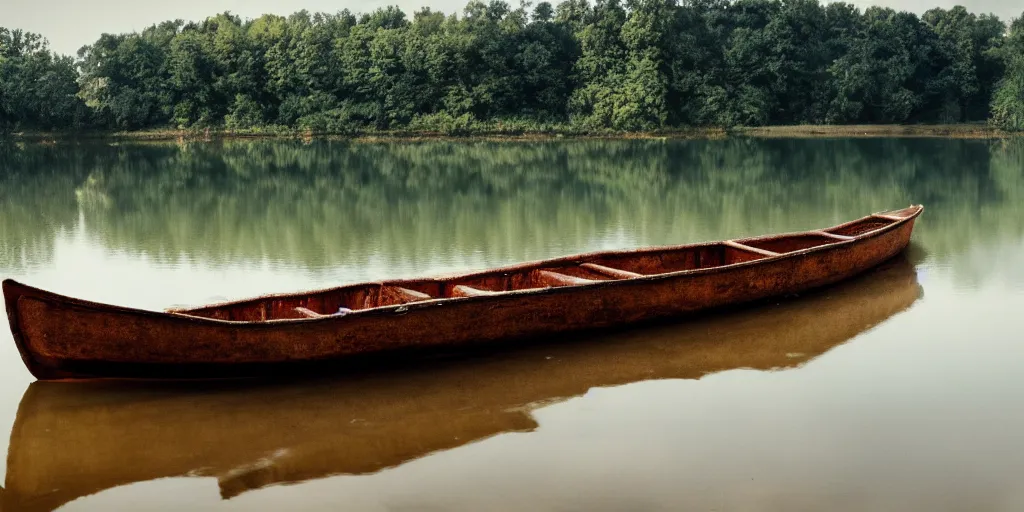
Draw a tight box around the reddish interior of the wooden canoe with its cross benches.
[173,207,916,322]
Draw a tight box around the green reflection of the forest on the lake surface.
[0,139,1024,278]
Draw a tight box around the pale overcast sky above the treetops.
[0,0,1024,54]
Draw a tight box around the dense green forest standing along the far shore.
[0,0,1024,134]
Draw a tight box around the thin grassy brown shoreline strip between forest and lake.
[6,124,1024,143]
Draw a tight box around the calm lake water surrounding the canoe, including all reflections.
[0,138,1024,512]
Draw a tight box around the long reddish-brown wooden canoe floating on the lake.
[3,206,923,380]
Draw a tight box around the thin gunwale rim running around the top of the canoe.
[3,205,925,327]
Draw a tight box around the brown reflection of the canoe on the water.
[2,252,923,511]
